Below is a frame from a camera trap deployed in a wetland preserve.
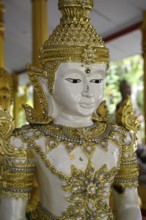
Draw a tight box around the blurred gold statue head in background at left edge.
[0,68,13,111]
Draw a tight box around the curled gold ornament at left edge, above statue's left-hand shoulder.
[0,106,14,155]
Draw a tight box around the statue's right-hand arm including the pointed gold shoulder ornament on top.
[112,97,142,220]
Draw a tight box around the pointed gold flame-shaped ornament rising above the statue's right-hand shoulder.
[116,96,140,133]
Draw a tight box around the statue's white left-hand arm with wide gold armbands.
[0,137,35,220]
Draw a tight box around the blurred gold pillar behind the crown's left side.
[32,0,48,114]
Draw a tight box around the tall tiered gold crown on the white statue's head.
[39,0,109,94]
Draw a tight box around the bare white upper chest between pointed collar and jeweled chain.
[34,140,120,176]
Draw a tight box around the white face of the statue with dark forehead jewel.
[52,63,106,117]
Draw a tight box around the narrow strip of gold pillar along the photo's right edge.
[142,11,146,144]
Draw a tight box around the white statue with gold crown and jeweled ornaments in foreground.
[0,0,141,220]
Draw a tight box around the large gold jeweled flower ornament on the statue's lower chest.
[63,161,116,220]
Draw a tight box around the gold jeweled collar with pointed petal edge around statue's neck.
[32,122,111,158]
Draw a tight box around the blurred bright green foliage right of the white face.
[105,55,144,113]
